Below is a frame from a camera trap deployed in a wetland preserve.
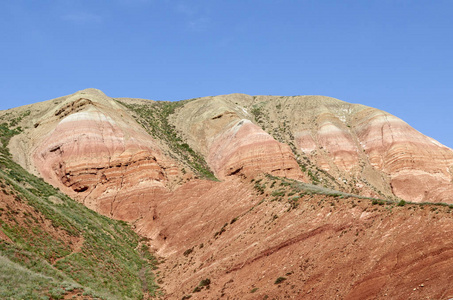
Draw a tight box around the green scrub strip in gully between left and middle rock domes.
[118,99,217,180]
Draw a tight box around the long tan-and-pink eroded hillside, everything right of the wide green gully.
[171,94,453,203]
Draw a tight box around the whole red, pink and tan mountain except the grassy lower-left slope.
[0,89,453,299]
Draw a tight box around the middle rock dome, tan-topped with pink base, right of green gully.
[174,95,306,180]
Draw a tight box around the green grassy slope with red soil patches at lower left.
[0,114,158,299]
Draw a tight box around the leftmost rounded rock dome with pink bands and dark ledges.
[33,91,182,214]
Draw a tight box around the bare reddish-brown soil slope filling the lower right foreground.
[139,175,453,299]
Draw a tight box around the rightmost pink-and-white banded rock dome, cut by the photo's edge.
[357,109,453,203]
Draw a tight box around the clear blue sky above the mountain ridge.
[0,0,453,147]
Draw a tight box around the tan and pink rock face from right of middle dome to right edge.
[205,95,453,203]
